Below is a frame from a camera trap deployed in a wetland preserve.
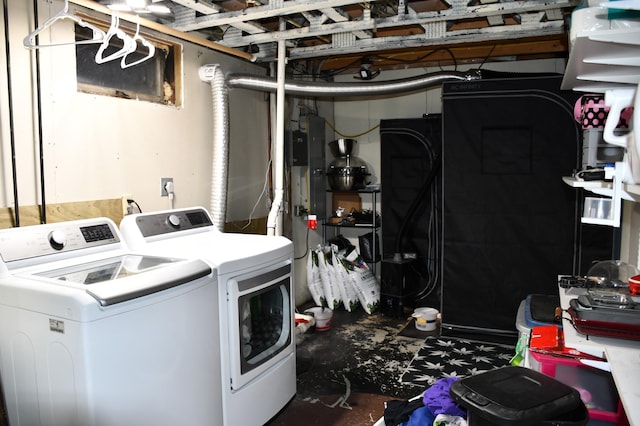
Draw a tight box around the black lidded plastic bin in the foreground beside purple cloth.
[450,367,589,426]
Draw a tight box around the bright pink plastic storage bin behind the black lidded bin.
[530,351,628,425]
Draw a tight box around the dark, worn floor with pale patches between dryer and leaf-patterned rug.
[269,309,437,426]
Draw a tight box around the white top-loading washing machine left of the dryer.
[0,218,222,426]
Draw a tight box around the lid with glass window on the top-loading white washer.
[35,254,212,306]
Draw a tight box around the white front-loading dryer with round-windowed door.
[120,207,296,426]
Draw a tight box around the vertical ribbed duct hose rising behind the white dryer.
[199,65,229,232]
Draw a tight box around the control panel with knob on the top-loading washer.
[0,218,120,262]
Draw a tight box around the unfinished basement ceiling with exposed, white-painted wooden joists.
[96,0,577,75]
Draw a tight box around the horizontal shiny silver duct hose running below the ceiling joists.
[227,71,479,97]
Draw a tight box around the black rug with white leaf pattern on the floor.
[400,337,515,387]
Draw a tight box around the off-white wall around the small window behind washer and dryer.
[0,0,269,221]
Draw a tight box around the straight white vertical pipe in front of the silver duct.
[267,21,287,235]
